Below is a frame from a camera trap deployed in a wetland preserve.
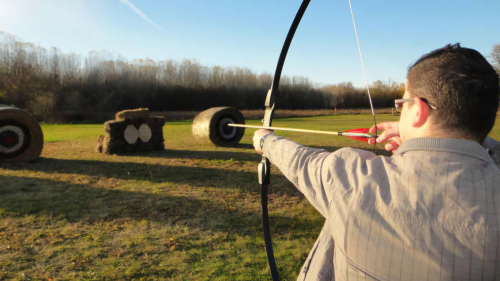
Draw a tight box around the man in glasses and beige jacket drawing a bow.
[254,44,500,280]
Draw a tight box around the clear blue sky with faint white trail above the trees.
[0,0,500,86]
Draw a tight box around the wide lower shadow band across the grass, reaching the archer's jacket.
[0,175,322,238]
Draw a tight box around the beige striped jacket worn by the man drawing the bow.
[263,136,500,280]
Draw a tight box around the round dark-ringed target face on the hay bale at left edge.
[0,120,30,158]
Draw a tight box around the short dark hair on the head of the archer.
[407,43,500,143]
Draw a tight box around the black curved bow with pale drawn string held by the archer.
[258,0,377,281]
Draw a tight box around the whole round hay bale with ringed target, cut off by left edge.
[0,107,43,163]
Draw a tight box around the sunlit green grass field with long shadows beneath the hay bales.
[0,115,500,280]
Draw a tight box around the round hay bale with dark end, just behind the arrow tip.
[191,107,245,147]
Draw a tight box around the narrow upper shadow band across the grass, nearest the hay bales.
[0,157,274,190]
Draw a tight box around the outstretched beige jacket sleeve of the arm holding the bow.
[263,136,375,218]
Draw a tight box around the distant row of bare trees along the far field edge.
[0,32,404,122]
